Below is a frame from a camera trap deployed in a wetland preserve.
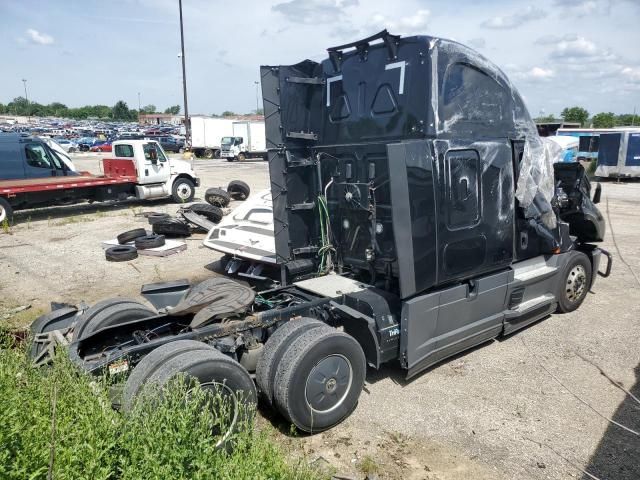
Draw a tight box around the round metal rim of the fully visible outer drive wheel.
[305,355,353,413]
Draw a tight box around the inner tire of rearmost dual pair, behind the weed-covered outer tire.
[122,340,213,411]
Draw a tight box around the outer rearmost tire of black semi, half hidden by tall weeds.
[129,349,257,449]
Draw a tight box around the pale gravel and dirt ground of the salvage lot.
[0,156,640,480]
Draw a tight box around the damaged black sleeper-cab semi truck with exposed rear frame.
[33,31,611,432]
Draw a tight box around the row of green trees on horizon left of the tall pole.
[0,97,180,122]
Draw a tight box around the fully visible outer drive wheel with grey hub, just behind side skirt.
[274,328,366,432]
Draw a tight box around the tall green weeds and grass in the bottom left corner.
[0,331,321,480]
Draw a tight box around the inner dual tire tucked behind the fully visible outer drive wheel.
[256,317,330,405]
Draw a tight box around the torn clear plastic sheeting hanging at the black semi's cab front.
[516,135,562,228]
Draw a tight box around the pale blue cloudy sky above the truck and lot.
[0,0,640,116]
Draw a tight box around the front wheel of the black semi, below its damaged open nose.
[556,251,591,313]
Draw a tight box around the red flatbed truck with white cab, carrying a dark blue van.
[0,134,200,223]
